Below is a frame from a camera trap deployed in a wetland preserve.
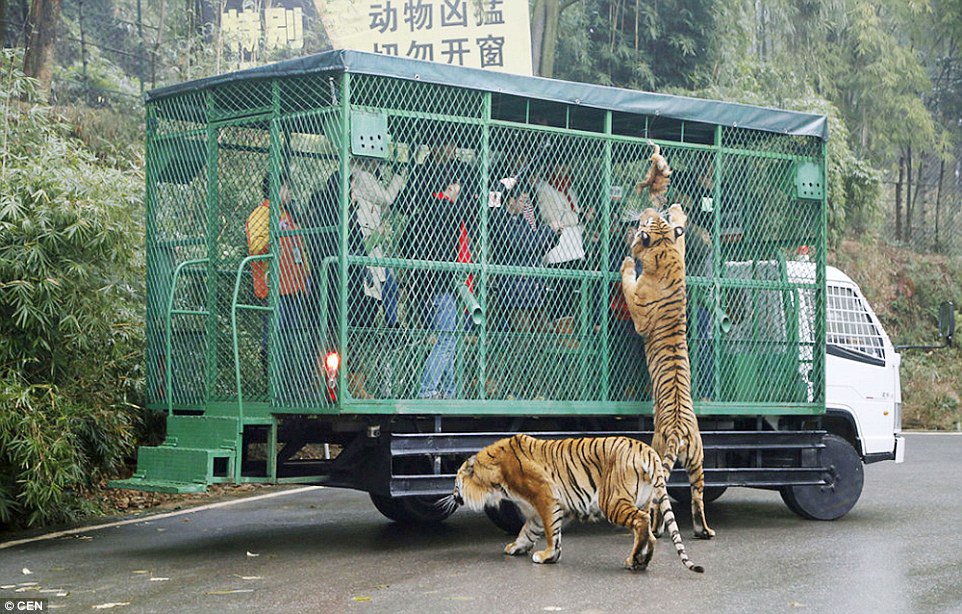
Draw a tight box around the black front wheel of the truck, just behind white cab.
[781,435,865,520]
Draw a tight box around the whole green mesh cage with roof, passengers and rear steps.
[112,51,828,498]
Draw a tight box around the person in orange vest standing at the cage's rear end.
[246,176,313,400]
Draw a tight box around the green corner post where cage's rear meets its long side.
[337,71,351,403]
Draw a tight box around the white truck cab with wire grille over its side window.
[824,266,905,463]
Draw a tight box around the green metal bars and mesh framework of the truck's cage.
[147,57,827,423]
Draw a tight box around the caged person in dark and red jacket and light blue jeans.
[400,161,477,399]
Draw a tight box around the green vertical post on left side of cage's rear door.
[204,90,220,402]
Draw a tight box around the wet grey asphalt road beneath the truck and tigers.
[0,435,962,614]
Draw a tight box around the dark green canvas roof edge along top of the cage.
[147,50,828,140]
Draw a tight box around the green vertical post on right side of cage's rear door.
[266,80,282,412]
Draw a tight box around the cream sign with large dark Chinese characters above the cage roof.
[315,0,531,75]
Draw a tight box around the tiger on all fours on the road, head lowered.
[452,435,704,573]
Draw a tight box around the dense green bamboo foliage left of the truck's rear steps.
[0,50,143,525]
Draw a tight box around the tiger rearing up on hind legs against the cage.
[621,204,715,539]
